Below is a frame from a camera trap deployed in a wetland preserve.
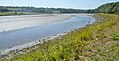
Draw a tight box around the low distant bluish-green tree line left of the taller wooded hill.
[0,6,95,13]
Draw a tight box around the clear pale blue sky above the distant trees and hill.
[0,0,119,9]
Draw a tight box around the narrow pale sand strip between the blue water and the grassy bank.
[0,31,69,54]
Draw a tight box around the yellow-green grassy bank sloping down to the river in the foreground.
[0,14,119,61]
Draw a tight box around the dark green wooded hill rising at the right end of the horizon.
[96,2,119,14]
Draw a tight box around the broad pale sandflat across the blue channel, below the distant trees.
[0,14,71,32]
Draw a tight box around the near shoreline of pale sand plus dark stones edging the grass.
[0,30,69,59]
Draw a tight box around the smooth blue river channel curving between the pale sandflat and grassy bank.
[0,15,95,50]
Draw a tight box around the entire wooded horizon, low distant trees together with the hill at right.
[0,2,119,14]
